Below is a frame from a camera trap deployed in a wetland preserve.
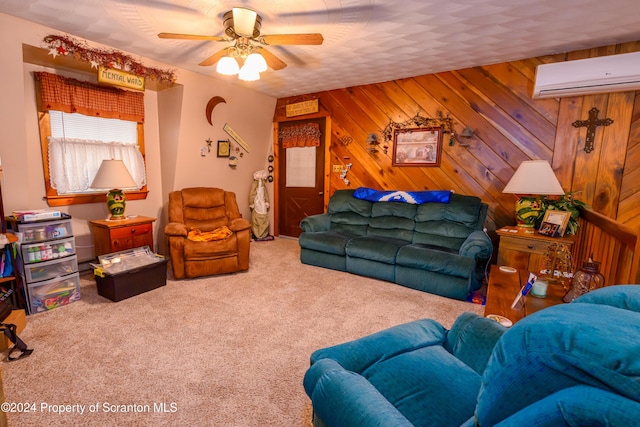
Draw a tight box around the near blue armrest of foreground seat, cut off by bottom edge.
[311,369,413,427]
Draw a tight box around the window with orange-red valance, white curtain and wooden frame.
[34,72,147,206]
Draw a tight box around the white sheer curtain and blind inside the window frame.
[49,110,146,194]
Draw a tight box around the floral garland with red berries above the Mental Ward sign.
[44,34,176,84]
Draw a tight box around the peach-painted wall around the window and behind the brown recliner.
[0,14,276,261]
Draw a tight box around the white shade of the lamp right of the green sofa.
[502,160,564,195]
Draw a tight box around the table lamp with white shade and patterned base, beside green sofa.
[502,160,565,233]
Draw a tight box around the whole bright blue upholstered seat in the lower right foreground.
[303,285,640,427]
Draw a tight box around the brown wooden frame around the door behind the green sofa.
[271,113,331,236]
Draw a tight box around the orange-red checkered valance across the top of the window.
[34,71,144,123]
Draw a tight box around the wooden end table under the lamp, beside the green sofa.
[496,227,576,274]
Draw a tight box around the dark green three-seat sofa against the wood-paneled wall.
[299,190,493,300]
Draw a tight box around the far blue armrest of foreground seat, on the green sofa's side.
[311,319,447,372]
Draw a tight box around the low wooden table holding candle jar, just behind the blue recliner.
[484,265,566,323]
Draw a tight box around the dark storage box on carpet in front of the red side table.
[93,258,169,302]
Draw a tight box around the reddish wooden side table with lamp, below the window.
[89,216,156,256]
